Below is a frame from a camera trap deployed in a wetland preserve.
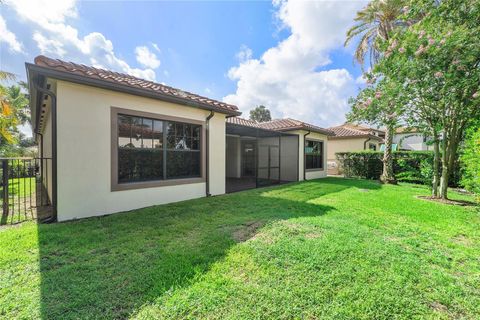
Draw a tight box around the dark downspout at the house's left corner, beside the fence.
[33,82,57,223]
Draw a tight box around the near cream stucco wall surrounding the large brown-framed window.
[57,81,225,221]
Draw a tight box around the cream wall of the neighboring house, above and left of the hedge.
[327,137,381,175]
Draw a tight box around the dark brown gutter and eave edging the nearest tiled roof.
[25,63,242,116]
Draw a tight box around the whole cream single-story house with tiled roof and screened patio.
[26,56,333,221]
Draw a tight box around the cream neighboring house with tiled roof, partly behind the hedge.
[327,123,385,175]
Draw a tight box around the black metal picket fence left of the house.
[0,158,52,225]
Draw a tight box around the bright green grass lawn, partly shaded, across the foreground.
[0,178,480,319]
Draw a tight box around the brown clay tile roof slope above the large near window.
[26,56,241,116]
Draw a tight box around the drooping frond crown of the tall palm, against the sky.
[344,0,405,68]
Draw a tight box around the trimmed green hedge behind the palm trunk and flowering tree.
[336,151,460,187]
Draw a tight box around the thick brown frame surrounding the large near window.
[110,106,206,191]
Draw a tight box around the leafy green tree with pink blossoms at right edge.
[375,0,480,199]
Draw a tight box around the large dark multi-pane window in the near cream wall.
[115,113,202,189]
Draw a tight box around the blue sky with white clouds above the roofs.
[0,0,364,126]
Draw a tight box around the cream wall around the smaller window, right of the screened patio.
[288,130,330,181]
